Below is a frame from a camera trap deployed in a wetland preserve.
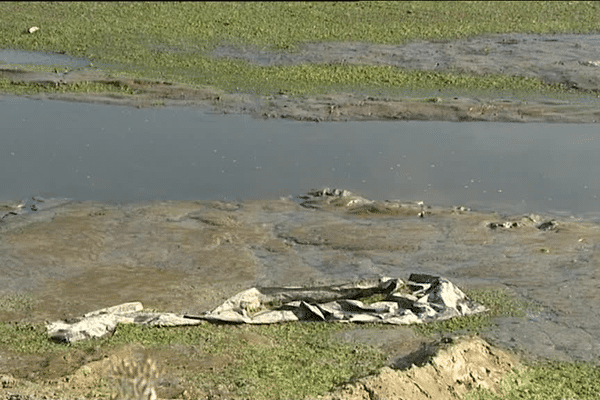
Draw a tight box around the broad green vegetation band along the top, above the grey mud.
[0,1,600,55]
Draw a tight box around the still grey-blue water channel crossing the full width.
[0,96,600,217]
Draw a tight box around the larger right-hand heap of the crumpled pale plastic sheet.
[199,274,485,325]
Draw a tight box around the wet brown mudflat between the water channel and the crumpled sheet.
[0,192,600,398]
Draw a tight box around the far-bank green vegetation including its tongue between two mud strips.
[0,2,600,94]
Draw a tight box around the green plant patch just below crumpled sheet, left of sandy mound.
[113,323,385,399]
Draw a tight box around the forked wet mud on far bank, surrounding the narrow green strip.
[0,34,600,123]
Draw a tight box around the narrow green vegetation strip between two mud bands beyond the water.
[198,61,562,95]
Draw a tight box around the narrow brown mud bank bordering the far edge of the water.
[0,69,600,123]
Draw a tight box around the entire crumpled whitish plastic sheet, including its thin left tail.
[47,274,486,343]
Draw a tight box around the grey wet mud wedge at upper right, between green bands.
[213,33,600,90]
